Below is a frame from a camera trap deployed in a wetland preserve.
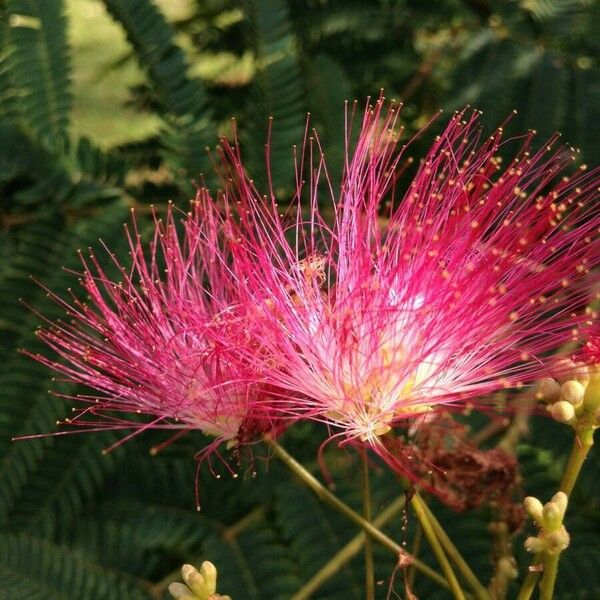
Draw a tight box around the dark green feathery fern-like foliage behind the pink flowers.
[0,0,600,600]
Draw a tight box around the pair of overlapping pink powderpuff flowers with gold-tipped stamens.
[25,99,600,492]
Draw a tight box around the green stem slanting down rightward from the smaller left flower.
[264,436,449,588]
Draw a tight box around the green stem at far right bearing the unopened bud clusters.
[517,430,594,600]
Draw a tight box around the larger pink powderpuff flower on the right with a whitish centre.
[216,98,600,474]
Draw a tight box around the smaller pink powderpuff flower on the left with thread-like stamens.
[22,198,270,468]
